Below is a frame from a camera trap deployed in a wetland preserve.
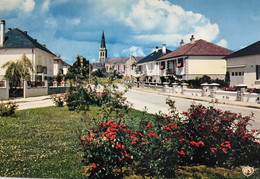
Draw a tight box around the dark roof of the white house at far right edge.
[225,41,260,58]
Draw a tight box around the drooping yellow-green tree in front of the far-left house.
[1,54,33,87]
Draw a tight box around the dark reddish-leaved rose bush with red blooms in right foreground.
[180,104,260,167]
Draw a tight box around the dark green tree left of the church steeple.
[65,55,89,81]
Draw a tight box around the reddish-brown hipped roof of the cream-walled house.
[159,39,233,60]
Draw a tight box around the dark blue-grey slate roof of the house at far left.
[1,28,56,56]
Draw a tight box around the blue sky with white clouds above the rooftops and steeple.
[0,0,260,64]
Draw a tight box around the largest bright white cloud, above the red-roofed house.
[92,0,219,45]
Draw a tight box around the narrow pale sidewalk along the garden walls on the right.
[132,87,260,109]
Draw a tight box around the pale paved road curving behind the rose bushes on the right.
[125,89,260,130]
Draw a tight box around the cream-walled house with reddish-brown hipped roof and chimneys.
[158,35,232,80]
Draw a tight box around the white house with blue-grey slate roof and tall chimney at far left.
[0,20,55,81]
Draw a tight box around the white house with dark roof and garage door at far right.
[225,41,260,88]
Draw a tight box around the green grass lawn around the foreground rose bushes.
[0,107,259,178]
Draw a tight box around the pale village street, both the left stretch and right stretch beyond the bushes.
[15,88,260,130]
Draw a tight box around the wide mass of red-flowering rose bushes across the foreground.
[79,95,260,178]
